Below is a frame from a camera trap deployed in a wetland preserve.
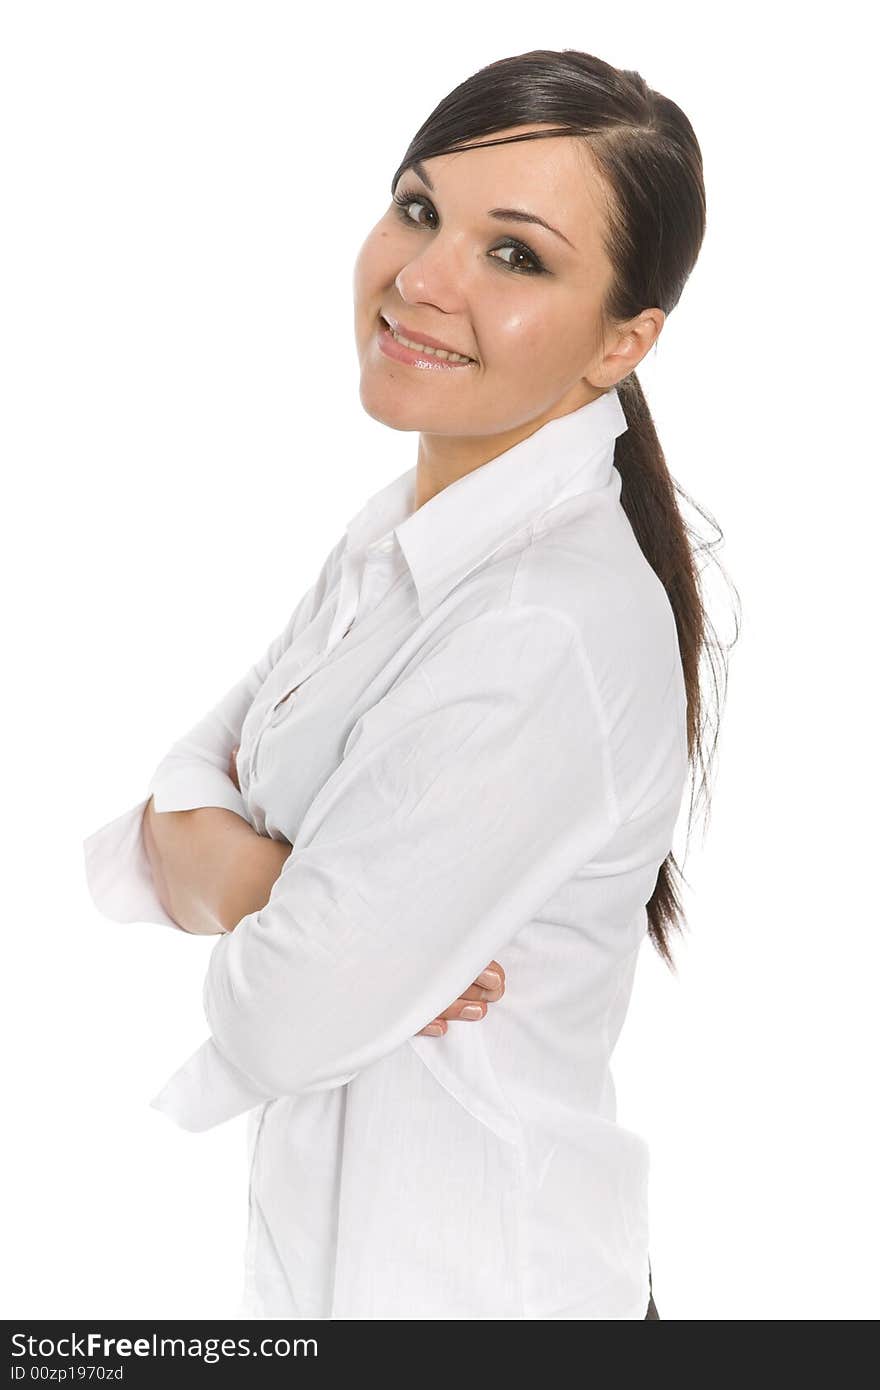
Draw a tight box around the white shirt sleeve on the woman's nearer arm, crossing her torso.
[150,606,620,1130]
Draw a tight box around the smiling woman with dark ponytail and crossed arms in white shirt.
[86,50,722,1319]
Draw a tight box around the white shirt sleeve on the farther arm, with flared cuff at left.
[83,545,338,931]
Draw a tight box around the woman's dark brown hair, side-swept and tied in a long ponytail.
[391,49,738,970]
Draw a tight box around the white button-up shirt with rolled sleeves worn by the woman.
[85,391,688,1319]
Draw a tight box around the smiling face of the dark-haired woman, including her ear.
[355,125,651,436]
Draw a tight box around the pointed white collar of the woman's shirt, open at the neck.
[345,388,627,617]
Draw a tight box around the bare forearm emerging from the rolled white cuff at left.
[143,798,291,935]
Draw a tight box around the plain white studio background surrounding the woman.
[0,0,880,1319]
